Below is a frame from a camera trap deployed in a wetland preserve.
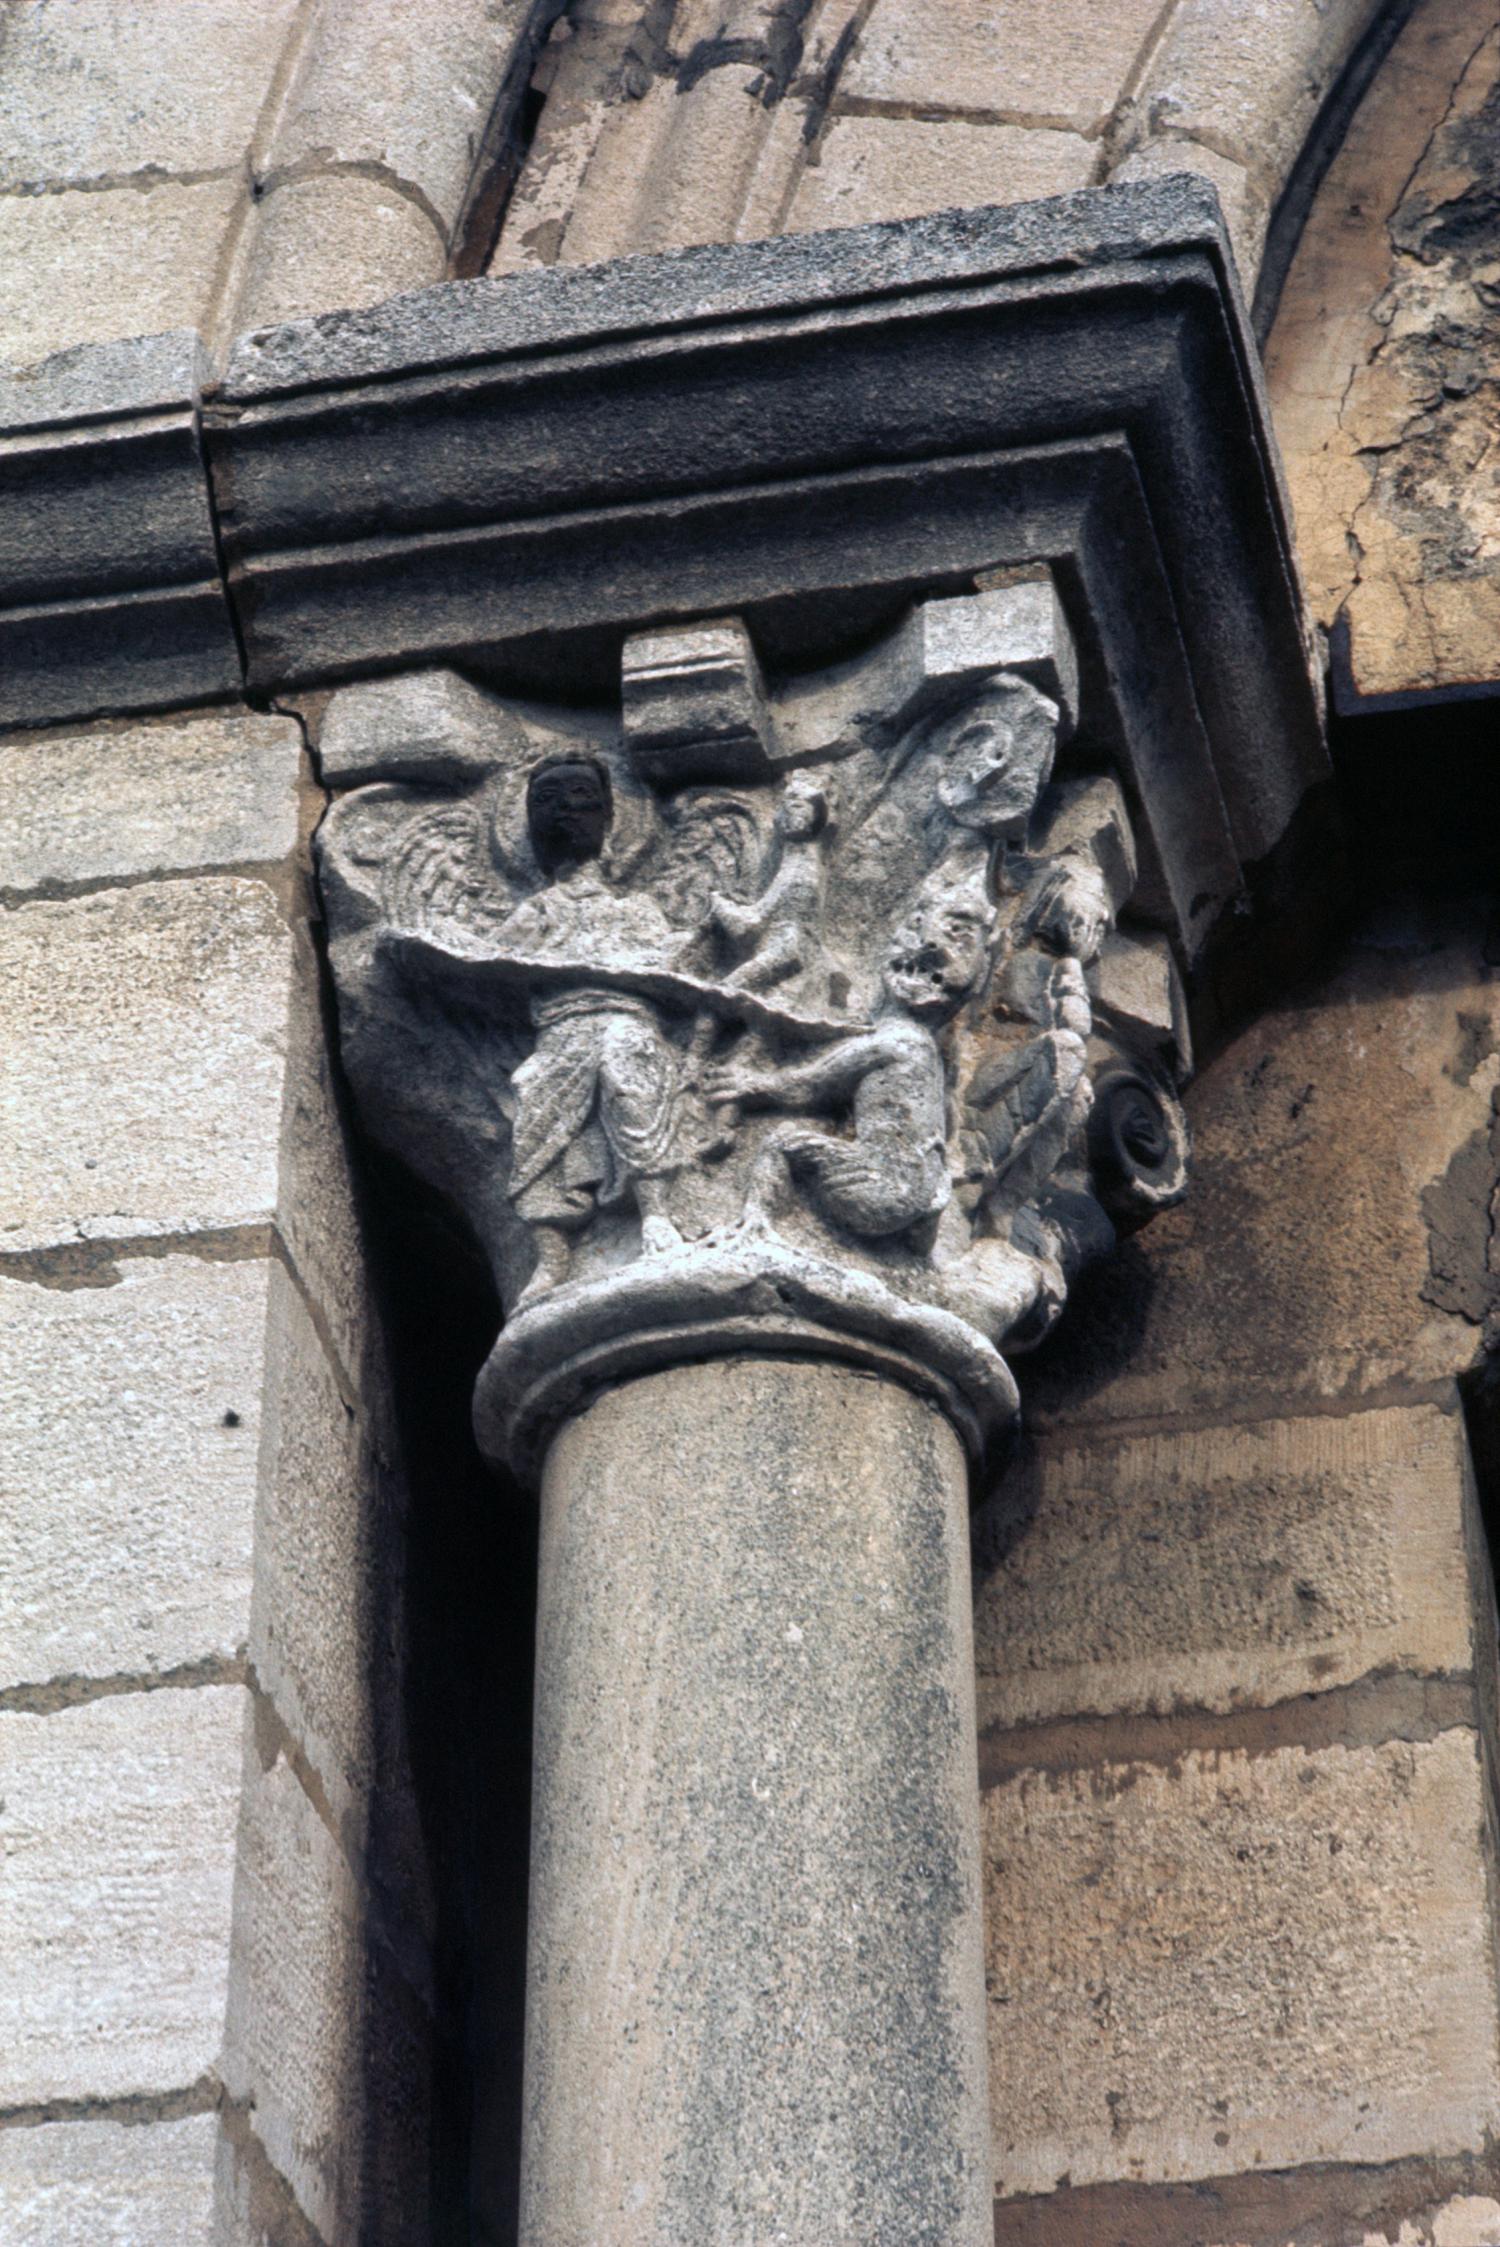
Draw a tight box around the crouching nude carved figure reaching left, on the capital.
[705,871,993,1238]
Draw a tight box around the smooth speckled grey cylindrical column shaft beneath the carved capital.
[521,1355,993,2247]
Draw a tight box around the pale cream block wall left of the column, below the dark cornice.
[0,708,431,2247]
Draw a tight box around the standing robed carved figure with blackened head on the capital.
[499,757,698,1308]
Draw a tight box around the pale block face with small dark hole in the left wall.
[0,1256,267,1687]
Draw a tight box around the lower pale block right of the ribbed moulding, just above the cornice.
[786,117,1096,234]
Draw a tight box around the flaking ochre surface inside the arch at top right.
[1266,0,1500,694]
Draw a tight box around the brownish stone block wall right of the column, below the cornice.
[975,901,1500,2247]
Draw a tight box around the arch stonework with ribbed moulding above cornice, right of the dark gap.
[492,0,1379,290]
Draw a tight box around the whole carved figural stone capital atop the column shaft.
[319,582,1186,1470]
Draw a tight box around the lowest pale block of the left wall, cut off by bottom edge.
[0,2114,218,2247]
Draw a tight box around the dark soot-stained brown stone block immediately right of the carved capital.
[1022,899,1500,1429]
